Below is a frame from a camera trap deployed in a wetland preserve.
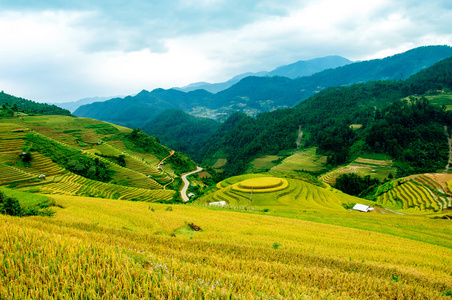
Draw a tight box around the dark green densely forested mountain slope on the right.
[196,58,452,176]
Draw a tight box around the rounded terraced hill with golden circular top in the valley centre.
[196,172,372,211]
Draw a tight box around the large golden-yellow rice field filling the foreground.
[0,194,452,300]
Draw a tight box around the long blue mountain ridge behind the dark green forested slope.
[74,46,452,127]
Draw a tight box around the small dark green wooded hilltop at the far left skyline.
[0,91,71,117]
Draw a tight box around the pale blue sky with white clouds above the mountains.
[0,0,452,102]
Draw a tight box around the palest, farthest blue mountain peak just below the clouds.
[175,55,352,93]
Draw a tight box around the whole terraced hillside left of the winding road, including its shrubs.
[0,116,195,202]
